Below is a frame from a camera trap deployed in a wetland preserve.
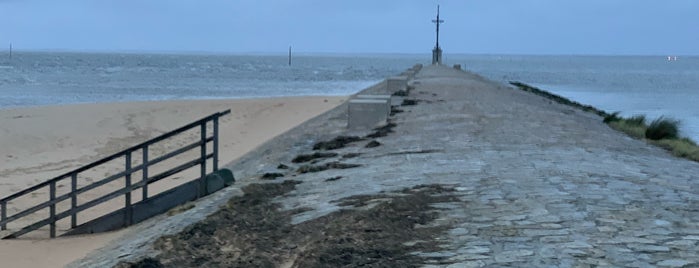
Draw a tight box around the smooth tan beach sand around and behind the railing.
[0,97,346,267]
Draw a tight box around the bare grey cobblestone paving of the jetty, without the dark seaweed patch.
[77,66,699,267]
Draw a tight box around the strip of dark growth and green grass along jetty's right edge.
[510,82,699,162]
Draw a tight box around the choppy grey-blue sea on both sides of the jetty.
[0,51,699,141]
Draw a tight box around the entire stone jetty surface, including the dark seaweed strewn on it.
[79,66,699,267]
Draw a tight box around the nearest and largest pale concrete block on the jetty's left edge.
[347,99,391,129]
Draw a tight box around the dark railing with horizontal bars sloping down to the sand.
[0,110,230,239]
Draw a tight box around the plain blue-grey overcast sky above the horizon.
[0,0,699,55]
